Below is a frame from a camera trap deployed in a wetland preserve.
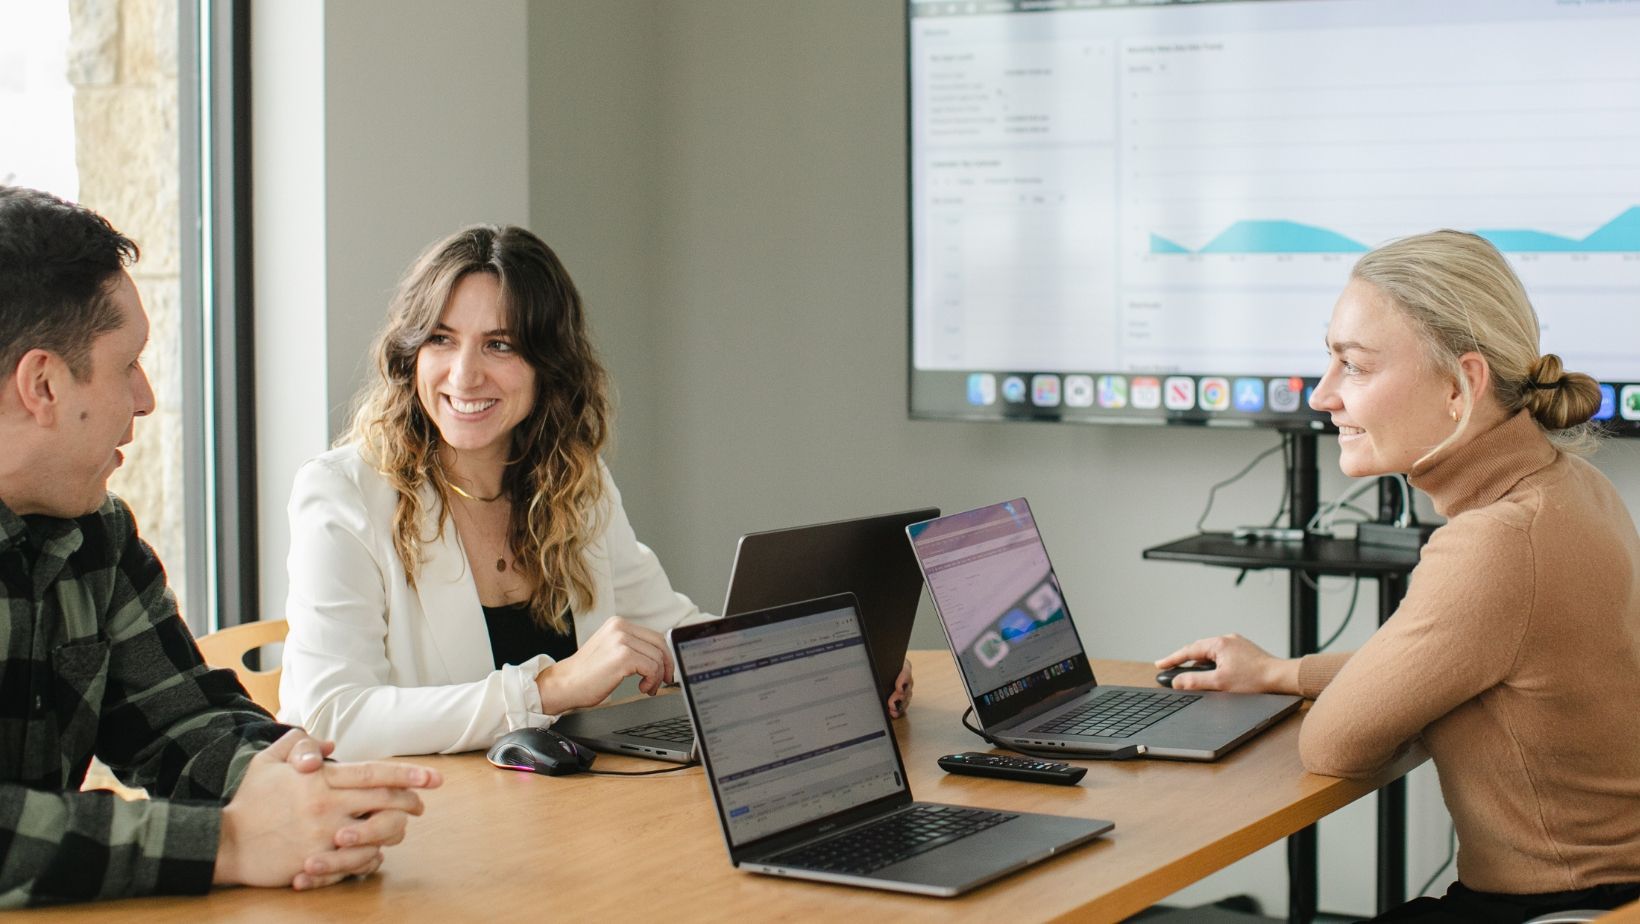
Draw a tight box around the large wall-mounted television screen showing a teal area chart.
[907,0,1640,435]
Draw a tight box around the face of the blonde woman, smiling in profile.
[1310,279,1463,478]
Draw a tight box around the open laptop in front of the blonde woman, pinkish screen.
[905,497,1299,760]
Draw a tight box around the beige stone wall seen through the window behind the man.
[67,0,188,629]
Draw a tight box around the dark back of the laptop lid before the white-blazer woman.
[723,507,940,699]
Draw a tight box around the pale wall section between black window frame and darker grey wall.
[251,0,530,630]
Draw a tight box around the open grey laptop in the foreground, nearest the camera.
[667,594,1114,896]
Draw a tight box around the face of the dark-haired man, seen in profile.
[55,271,154,517]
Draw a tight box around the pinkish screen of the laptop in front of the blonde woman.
[907,497,1092,722]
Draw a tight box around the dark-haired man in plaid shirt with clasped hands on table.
[0,187,440,908]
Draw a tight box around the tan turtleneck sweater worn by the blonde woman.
[1299,412,1640,894]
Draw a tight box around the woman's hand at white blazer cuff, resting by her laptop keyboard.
[535,617,672,716]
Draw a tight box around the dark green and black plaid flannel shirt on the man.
[0,494,285,908]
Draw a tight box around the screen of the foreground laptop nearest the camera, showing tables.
[677,597,905,847]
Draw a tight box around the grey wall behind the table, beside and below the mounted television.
[530,0,1640,914]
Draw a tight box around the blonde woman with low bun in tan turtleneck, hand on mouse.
[1156,231,1640,922]
